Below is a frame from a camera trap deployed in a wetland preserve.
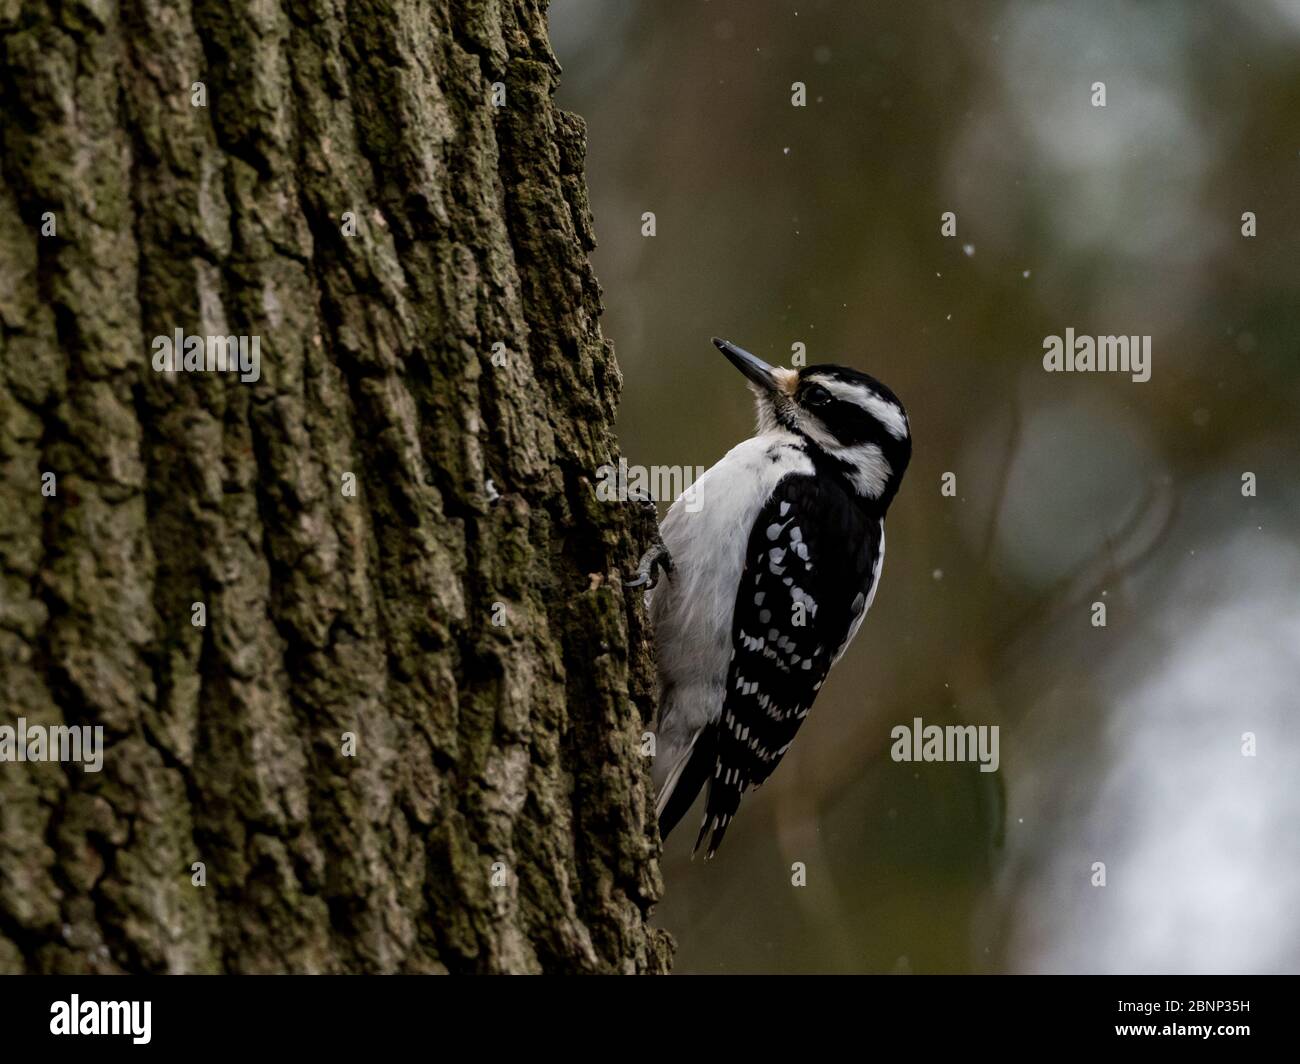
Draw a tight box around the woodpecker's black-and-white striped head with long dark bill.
[714,337,911,507]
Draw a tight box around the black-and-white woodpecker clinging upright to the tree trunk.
[641,339,911,857]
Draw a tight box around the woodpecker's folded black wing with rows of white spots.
[683,476,884,857]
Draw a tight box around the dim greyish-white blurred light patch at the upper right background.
[946,0,1216,332]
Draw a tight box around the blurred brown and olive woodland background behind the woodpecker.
[550,0,1300,973]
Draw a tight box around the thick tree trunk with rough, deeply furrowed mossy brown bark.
[0,0,670,972]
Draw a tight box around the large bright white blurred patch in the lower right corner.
[1002,525,1300,973]
